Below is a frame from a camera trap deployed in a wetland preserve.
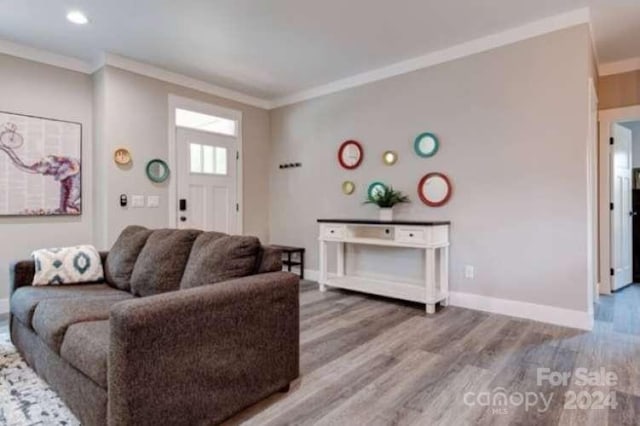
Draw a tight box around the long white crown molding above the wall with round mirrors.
[272,7,591,108]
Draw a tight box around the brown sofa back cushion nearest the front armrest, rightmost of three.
[180,232,260,288]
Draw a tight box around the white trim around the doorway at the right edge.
[598,105,640,294]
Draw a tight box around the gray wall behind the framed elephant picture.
[0,54,94,299]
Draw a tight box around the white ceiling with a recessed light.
[0,0,640,99]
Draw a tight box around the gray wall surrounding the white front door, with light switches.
[95,67,270,247]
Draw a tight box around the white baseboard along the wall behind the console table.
[304,269,593,330]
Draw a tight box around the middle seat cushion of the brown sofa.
[33,292,133,353]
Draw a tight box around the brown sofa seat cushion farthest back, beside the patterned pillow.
[11,284,130,328]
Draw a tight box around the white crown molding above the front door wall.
[98,53,272,109]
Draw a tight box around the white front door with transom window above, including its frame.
[168,95,243,234]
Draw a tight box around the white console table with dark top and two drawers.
[318,219,450,314]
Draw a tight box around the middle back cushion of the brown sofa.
[131,229,202,296]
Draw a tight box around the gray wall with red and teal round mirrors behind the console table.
[270,25,592,311]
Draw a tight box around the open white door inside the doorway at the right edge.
[611,124,633,290]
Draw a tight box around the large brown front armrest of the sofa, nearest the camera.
[108,272,300,425]
